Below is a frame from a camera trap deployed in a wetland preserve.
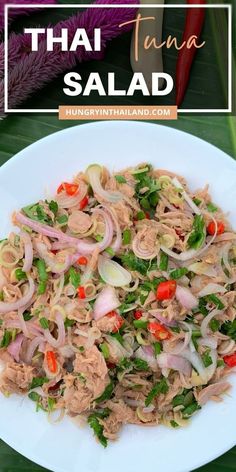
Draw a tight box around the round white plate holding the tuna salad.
[0,122,236,472]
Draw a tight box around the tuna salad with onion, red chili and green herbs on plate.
[0,163,236,447]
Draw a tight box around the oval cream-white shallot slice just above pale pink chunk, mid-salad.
[98,255,132,287]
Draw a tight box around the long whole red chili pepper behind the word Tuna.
[176,0,206,106]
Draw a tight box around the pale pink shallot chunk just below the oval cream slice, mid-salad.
[93,285,121,320]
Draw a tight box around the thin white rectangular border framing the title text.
[4,3,232,113]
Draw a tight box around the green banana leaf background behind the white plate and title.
[0,0,236,472]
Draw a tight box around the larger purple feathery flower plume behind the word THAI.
[0,0,137,110]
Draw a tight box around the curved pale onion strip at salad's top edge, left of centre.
[86,164,123,203]
